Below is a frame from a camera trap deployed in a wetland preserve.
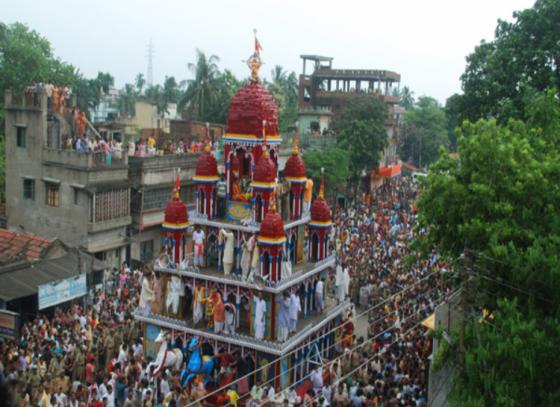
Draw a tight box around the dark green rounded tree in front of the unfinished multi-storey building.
[333,97,387,192]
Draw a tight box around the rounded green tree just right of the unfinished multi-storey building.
[399,96,448,167]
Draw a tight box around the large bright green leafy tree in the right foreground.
[418,90,560,406]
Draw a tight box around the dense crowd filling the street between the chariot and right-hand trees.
[312,177,448,407]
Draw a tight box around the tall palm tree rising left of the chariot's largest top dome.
[180,49,220,119]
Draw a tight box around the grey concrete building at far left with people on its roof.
[5,91,131,266]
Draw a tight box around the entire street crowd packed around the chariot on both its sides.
[0,177,446,407]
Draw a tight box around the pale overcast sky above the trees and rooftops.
[5,0,534,102]
